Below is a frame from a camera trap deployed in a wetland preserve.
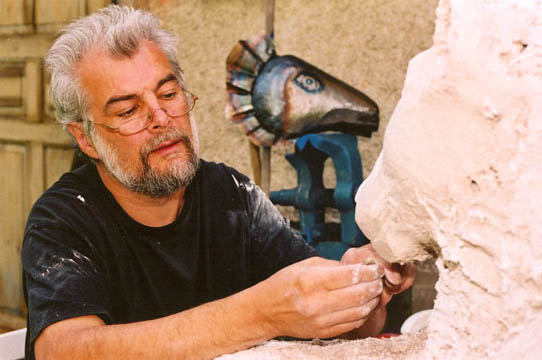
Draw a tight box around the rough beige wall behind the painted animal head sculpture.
[150,0,437,202]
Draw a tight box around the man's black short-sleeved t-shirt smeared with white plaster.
[22,160,316,359]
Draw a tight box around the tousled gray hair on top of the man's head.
[45,5,184,134]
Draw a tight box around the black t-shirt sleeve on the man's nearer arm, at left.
[22,224,110,358]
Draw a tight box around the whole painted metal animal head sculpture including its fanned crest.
[226,36,378,146]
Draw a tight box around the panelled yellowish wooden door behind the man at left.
[0,0,115,329]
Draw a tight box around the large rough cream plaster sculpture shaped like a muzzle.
[356,0,542,360]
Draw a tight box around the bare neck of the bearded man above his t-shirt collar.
[96,164,185,227]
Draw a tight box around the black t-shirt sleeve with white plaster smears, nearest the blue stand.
[233,172,318,283]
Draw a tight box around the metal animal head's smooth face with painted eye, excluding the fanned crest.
[252,55,379,138]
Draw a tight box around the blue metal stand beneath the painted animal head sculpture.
[270,134,367,259]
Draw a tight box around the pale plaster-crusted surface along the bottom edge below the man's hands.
[217,333,427,360]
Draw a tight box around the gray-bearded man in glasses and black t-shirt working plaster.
[22,6,414,359]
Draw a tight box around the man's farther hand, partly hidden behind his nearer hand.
[341,244,416,305]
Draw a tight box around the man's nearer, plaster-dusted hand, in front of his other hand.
[254,257,384,338]
